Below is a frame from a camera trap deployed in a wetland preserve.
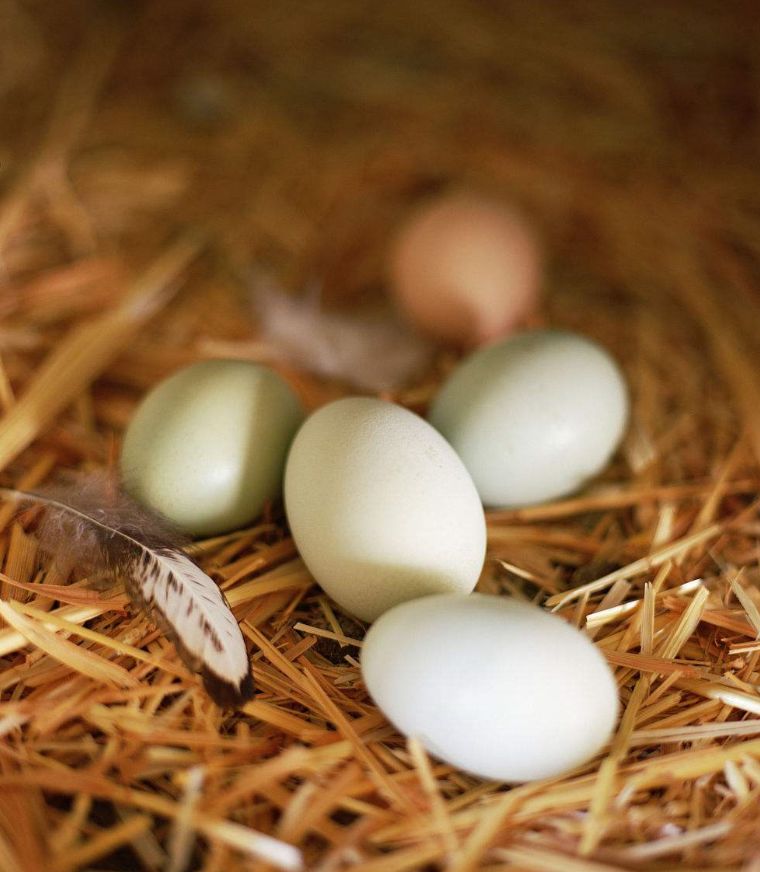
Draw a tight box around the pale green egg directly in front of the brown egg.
[428,330,628,507]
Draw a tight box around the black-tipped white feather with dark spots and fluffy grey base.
[0,476,253,707]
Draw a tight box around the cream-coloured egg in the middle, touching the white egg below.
[285,397,486,621]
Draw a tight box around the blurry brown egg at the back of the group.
[389,192,541,346]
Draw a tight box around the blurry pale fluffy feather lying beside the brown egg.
[254,280,433,391]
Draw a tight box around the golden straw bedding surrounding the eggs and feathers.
[0,0,760,872]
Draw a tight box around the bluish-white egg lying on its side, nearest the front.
[361,594,618,782]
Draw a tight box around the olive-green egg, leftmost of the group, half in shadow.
[121,360,303,536]
